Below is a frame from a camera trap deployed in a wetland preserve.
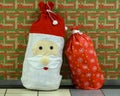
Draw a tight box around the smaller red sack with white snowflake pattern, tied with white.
[65,26,104,90]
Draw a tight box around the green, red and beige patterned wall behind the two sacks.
[0,0,120,80]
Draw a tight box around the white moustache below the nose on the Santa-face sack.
[27,55,62,70]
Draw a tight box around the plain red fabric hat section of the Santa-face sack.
[30,2,65,37]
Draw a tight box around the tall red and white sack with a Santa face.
[21,2,65,90]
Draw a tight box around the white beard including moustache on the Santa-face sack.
[21,55,62,90]
